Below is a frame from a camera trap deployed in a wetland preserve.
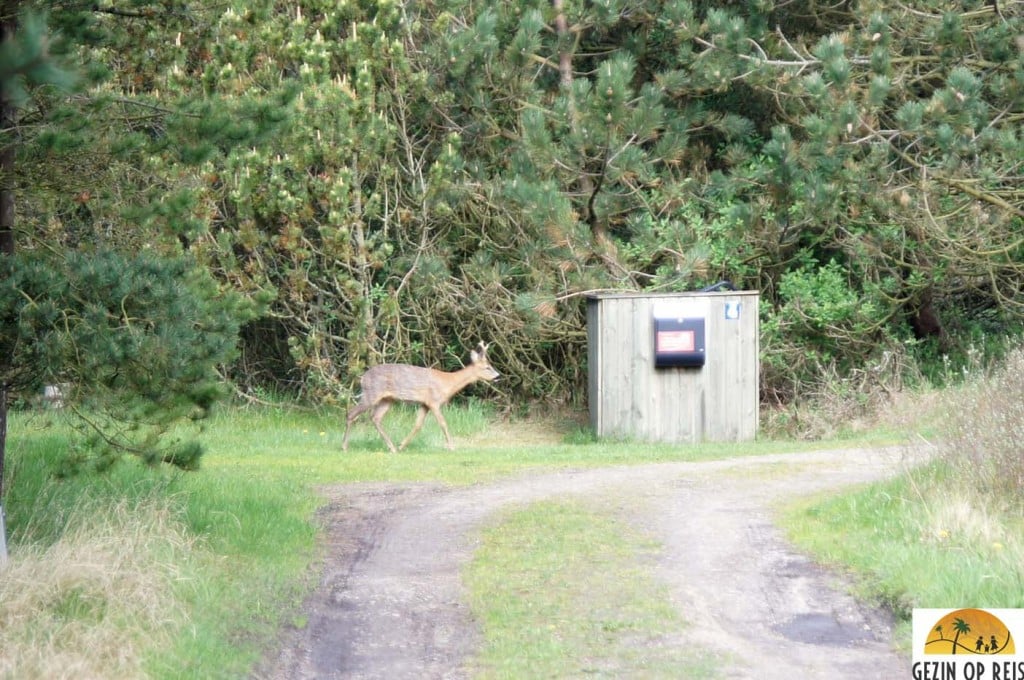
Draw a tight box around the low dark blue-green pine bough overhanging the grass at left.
[0,252,244,469]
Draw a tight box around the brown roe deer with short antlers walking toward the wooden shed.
[341,341,501,453]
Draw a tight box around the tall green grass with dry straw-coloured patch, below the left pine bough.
[0,430,195,679]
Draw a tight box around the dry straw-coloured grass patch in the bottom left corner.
[0,501,190,680]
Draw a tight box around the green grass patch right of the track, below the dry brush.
[782,464,1024,653]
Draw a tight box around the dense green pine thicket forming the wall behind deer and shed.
[0,0,1024,409]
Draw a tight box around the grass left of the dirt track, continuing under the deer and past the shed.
[0,401,810,680]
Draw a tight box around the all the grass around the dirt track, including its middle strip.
[0,350,1024,680]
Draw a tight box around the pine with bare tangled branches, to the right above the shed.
[696,2,1024,393]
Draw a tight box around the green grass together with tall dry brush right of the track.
[785,350,1024,645]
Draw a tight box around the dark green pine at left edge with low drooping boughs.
[0,2,288,489]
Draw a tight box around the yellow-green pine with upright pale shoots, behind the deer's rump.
[198,3,411,397]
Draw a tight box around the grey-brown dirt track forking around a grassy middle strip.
[256,450,929,680]
